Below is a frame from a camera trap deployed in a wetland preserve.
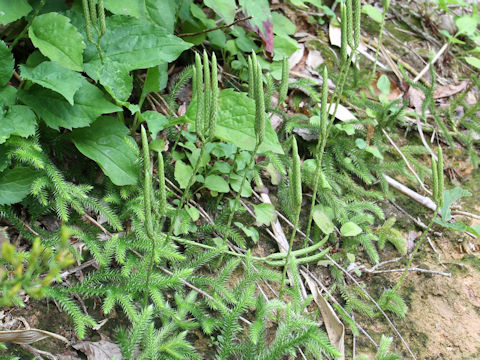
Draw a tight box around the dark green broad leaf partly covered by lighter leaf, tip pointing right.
[18,80,122,130]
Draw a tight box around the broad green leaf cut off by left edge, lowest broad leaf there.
[0,167,36,205]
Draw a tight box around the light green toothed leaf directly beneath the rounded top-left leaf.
[20,61,84,105]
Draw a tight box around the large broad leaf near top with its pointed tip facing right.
[85,15,192,74]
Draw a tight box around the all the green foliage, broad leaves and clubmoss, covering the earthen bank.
[0,0,480,360]
